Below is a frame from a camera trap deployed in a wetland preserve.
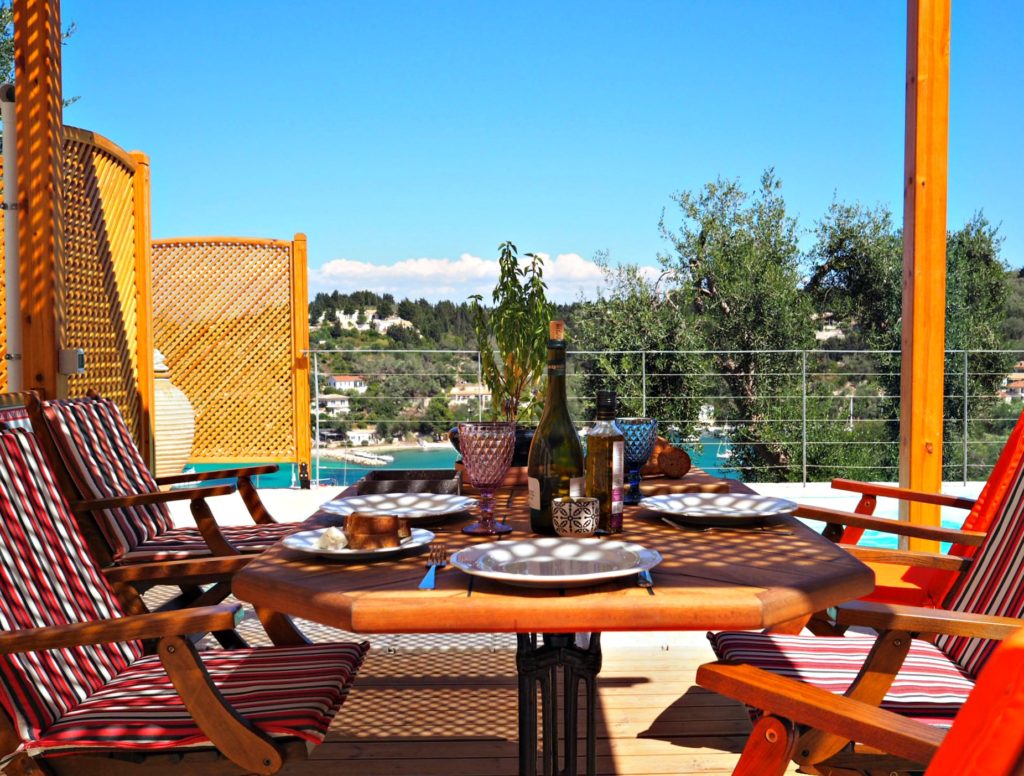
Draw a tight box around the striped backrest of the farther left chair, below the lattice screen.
[41,396,173,560]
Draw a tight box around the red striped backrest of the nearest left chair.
[0,430,141,763]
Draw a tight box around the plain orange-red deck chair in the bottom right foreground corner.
[697,630,1024,776]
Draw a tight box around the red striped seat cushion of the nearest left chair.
[27,643,369,755]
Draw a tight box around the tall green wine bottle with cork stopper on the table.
[526,320,585,534]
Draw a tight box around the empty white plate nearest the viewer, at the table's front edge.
[451,536,662,588]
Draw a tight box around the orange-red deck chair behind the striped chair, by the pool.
[779,414,1024,635]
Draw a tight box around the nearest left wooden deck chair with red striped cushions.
[0,430,367,776]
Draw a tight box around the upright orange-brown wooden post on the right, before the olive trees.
[899,0,949,552]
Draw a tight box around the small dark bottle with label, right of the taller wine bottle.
[587,391,626,533]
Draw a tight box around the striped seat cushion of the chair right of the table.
[708,631,974,727]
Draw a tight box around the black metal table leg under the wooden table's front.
[516,633,601,776]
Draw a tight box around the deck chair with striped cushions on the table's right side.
[709,456,1024,773]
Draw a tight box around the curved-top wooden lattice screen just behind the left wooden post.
[0,127,153,455]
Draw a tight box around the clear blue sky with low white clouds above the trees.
[62,0,1024,300]
